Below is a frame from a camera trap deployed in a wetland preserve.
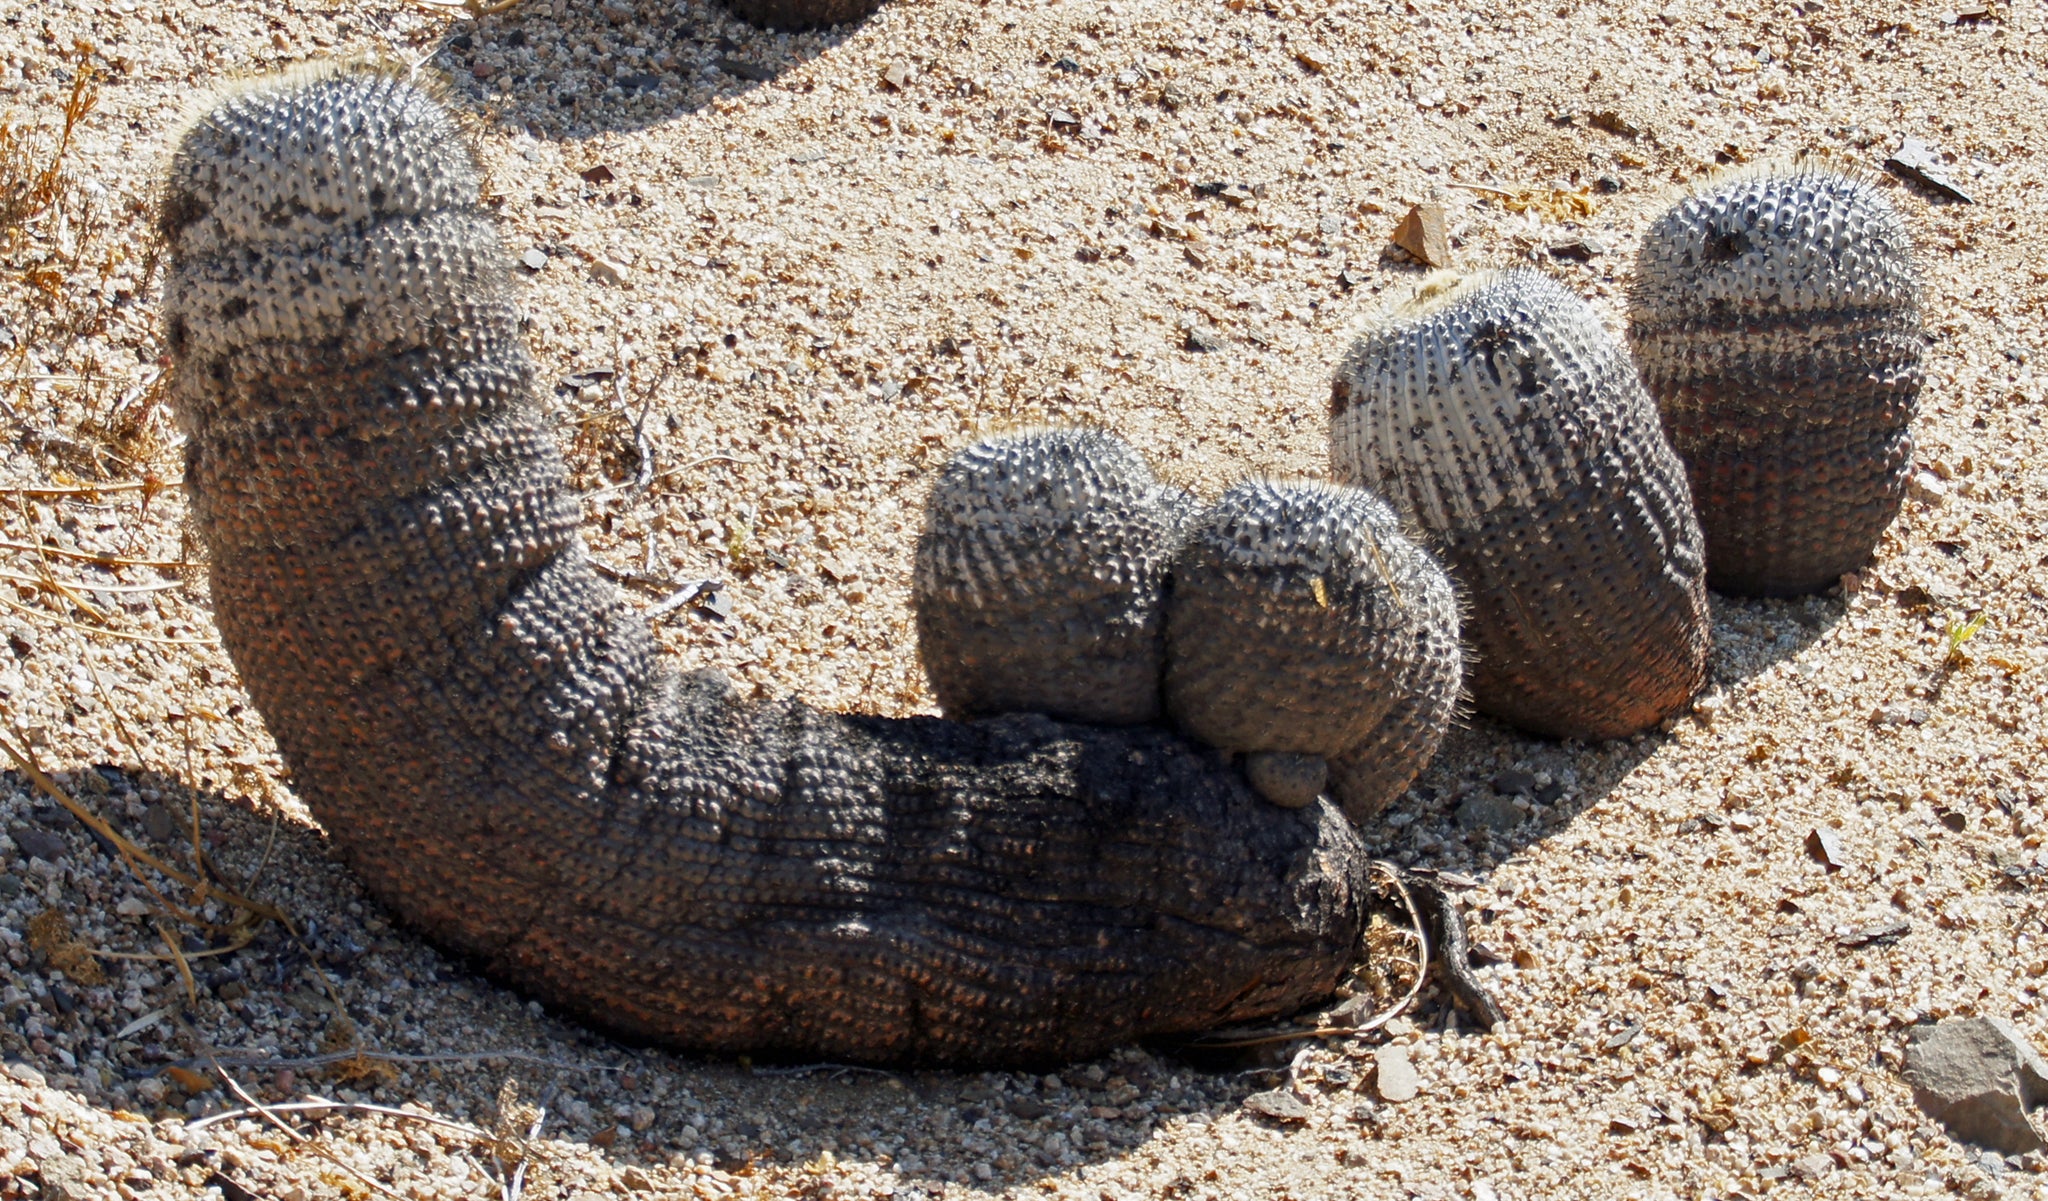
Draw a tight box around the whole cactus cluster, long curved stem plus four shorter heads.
[160,60,1919,1064]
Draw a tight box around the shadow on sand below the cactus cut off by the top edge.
[430,0,858,140]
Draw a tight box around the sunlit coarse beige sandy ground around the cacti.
[0,0,2048,1201]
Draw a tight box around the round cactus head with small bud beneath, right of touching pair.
[1165,480,1460,816]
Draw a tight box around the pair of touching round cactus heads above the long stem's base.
[913,444,1458,820]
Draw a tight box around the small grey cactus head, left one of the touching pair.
[911,430,1192,726]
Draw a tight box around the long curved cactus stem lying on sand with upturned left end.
[160,70,1366,1064]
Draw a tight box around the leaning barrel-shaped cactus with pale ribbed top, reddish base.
[1329,271,1710,738]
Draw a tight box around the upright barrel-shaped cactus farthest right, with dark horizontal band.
[1628,158,1925,596]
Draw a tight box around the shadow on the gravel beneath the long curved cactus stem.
[0,764,1392,1199]
